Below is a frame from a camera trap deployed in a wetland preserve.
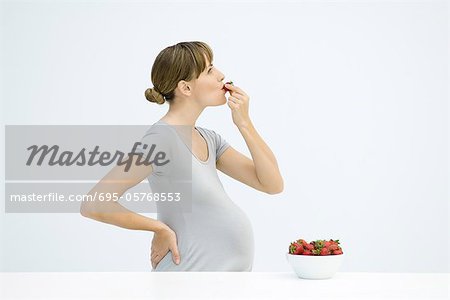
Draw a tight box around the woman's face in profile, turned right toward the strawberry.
[192,59,227,106]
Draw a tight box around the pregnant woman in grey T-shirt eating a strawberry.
[81,42,283,271]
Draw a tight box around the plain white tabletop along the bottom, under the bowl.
[0,272,450,300]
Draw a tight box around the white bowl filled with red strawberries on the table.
[286,239,344,279]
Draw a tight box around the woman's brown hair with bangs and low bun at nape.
[145,41,213,104]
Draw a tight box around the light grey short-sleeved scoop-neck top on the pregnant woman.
[135,120,254,272]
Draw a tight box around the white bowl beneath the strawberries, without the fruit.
[286,253,344,279]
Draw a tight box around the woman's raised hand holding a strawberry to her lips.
[225,83,250,127]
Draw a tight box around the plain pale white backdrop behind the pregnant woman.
[0,1,450,272]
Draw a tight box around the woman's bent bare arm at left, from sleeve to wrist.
[80,155,164,232]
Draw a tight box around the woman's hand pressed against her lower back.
[150,224,180,269]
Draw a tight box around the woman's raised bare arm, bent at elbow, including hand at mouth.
[216,84,283,194]
